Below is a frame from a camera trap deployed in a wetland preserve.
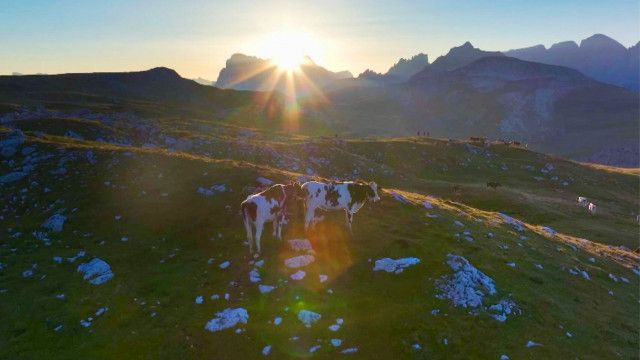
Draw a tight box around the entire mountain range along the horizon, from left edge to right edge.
[0,35,640,166]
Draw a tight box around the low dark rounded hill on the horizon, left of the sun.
[0,67,280,114]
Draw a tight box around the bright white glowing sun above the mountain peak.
[260,29,319,71]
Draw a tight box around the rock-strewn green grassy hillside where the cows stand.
[0,116,640,359]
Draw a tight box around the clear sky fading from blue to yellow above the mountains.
[0,0,640,80]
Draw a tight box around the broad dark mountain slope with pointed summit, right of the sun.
[307,55,640,166]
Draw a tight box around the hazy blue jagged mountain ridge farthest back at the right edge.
[504,34,640,91]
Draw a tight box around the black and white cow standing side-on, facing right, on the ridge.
[302,181,380,230]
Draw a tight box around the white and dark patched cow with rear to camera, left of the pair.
[240,182,302,254]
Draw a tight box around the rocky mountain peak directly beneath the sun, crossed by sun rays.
[216,54,353,96]
